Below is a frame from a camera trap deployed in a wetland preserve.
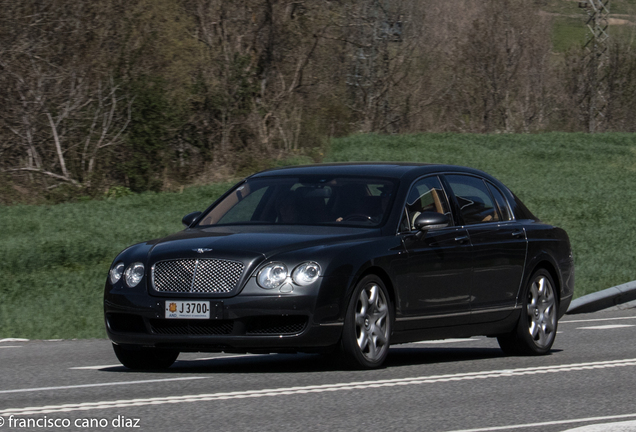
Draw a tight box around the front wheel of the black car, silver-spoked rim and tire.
[340,275,393,369]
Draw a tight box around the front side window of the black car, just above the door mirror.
[400,176,451,232]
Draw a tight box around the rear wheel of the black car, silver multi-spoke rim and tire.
[497,269,559,355]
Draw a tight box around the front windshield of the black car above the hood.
[198,177,396,227]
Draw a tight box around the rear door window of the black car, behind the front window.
[446,175,499,225]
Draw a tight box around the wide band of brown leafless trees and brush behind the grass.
[0,0,636,201]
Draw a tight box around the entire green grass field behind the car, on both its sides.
[0,133,636,339]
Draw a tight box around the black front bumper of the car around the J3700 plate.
[104,285,342,353]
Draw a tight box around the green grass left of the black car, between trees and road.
[0,183,230,339]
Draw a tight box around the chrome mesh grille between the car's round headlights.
[152,259,243,293]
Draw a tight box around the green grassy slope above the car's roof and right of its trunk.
[330,133,636,296]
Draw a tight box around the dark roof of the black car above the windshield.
[250,162,491,179]
